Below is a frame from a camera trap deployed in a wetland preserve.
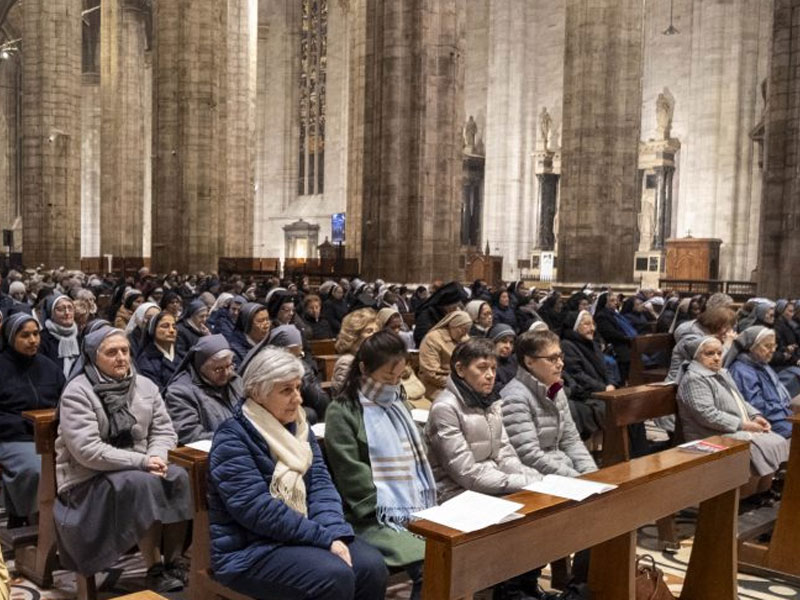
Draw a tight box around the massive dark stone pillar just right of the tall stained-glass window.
[360,0,466,281]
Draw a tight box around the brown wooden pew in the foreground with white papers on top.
[409,437,750,600]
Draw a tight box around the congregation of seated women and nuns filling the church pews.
[0,269,800,600]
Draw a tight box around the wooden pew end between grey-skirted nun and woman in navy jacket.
[169,447,249,600]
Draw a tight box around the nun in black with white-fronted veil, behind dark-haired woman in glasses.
[561,310,616,439]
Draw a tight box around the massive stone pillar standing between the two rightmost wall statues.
[557,0,643,283]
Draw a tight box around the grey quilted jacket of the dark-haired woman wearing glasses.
[500,367,597,477]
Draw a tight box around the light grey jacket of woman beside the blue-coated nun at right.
[678,361,759,440]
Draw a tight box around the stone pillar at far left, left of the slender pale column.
[22,0,82,268]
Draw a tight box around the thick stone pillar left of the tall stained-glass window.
[152,0,257,271]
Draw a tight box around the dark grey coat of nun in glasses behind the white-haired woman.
[164,366,244,446]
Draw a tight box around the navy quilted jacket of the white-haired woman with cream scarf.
[208,409,354,583]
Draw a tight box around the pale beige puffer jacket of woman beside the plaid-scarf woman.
[425,378,542,502]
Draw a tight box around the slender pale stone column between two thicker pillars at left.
[100,0,151,259]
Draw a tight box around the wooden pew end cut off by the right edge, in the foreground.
[739,416,800,585]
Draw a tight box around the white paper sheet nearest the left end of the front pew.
[414,492,524,532]
